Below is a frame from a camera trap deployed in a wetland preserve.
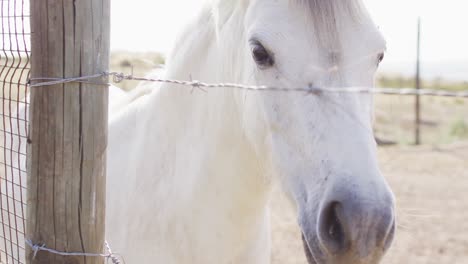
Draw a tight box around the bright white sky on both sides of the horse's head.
[111,0,468,62]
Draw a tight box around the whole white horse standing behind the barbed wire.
[107,0,395,264]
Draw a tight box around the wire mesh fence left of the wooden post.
[0,0,31,263]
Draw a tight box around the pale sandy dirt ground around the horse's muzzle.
[273,142,468,264]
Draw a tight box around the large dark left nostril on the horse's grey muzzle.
[319,202,347,254]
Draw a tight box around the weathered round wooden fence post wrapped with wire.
[26,0,110,264]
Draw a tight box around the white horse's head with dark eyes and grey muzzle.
[208,0,395,264]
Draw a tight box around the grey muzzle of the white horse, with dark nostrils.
[299,184,395,264]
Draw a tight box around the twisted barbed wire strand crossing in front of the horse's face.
[28,72,468,98]
